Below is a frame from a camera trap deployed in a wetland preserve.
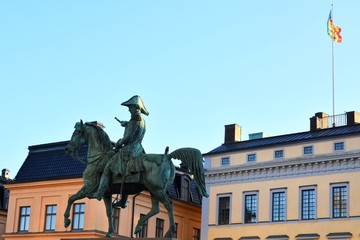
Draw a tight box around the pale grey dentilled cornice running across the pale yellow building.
[205,153,360,185]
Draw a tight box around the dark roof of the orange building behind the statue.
[13,141,201,205]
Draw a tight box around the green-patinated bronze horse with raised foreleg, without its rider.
[64,121,209,237]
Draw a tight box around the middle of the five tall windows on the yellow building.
[271,190,286,222]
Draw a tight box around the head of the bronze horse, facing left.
[65,120,88,157]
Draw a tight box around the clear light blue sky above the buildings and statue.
[0,0,360,177]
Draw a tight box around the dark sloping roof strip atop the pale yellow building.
[204,124,360,156]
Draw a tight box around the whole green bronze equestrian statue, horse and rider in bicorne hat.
[64,96,208,238]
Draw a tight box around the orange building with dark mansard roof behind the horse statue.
[2,142,201,240]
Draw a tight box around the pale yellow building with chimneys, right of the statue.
[201,112,360,240]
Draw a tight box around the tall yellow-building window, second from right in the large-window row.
[300,188,316,220]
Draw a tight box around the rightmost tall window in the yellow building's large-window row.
[331,184,348,218]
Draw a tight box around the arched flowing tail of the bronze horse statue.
[168,148,209,197]
